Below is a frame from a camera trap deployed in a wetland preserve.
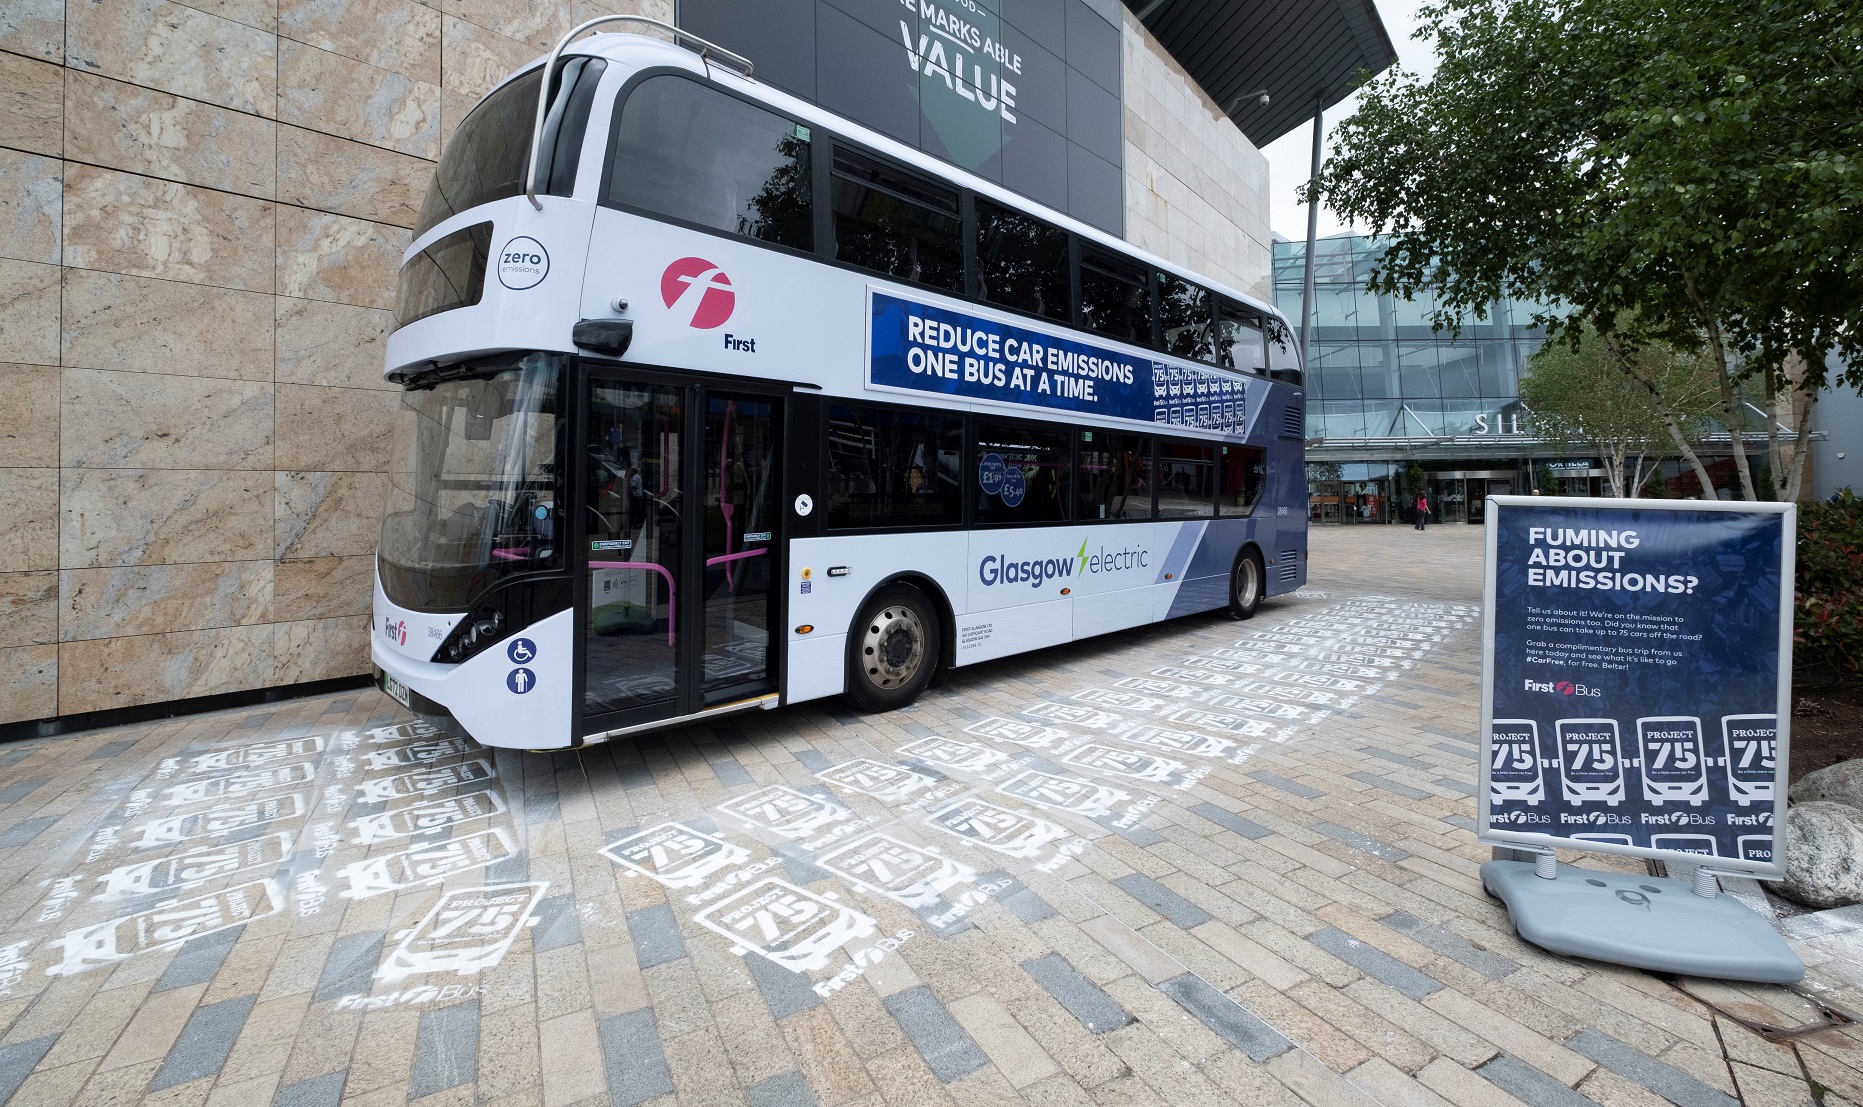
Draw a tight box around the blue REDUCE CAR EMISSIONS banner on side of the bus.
[866,289,1248,434]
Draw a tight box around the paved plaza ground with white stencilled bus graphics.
[0,527,1863,1107]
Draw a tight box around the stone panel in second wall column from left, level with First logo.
[63,268,272,380]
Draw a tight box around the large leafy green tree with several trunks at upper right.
[1317,0,1863,499]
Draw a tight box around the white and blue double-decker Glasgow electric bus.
[371,17,1306,749]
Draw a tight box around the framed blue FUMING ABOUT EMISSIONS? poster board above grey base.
[1481,498,1792,870]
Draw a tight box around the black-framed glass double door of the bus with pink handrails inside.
[578,369,782,734]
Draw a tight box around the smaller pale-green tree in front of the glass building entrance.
[1520,328,1716,496]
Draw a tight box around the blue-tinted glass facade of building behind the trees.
[1274,235,1544,439]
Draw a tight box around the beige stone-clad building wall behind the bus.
[0,0,1269,723]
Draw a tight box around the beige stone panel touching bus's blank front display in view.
[278,207,410,309]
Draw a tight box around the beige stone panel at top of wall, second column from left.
[67,0,278,117]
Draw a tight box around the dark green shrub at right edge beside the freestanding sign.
[1792,488,1863,678]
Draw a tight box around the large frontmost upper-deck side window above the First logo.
[602,76,814,250]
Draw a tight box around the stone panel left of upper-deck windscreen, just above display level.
[278,127,434,227]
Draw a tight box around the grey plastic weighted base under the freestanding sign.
[1481,861,1805,984]
